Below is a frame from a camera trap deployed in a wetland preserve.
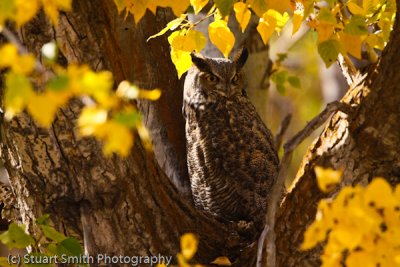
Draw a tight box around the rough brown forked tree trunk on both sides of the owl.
[0,0,400,266]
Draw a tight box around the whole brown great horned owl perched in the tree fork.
[183,49,279,230]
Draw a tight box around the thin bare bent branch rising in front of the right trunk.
[257,101,349,267]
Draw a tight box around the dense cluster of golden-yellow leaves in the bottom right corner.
[301,167,400,267]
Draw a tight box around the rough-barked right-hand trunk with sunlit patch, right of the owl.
[275,1,400,267]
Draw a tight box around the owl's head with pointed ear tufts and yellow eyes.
[184,48,248,103]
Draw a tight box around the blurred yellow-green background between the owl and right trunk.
[247,22,348,187]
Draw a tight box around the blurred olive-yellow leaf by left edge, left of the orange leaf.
[4,73,33,119]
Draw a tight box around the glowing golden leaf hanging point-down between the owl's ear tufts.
[208,20,235,58]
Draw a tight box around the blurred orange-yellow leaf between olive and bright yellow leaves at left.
[28,91,69,127]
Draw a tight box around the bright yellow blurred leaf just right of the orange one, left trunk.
[78,107,107,136]
